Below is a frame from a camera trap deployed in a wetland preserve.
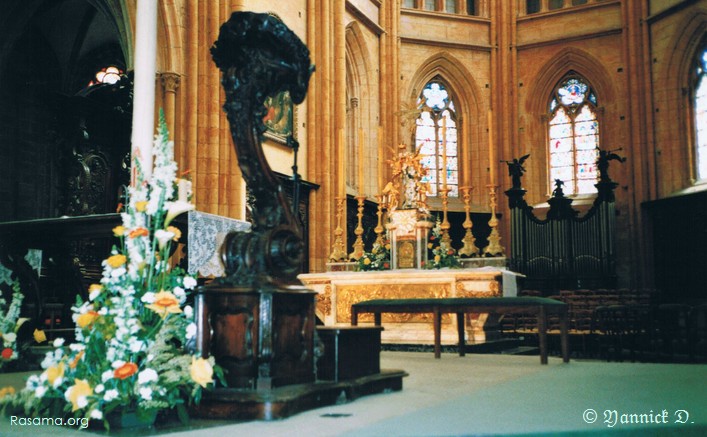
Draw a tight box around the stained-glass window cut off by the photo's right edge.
[693,43,707,180]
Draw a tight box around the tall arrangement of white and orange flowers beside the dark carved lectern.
[2,117,222,428]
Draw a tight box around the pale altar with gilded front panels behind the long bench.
[299,268,503,344]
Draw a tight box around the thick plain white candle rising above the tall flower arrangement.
[131,0,157,184]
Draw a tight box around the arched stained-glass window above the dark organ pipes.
[549,75,599,195]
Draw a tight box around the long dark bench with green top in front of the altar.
[351,297,570,364]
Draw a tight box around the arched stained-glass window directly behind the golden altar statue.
[415,78,459,197]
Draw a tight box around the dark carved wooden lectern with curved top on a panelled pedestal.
[191,12,405,419]
